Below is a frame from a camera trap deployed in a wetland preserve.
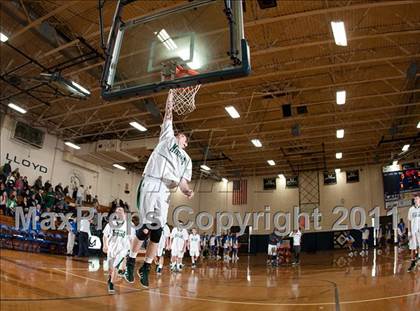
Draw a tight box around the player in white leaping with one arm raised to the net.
[125,93,193,288]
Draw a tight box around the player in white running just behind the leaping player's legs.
[102,206,134,294]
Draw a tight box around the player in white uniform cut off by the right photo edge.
[407,194,420,272]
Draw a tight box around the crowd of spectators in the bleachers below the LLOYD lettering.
[0,163,99,216]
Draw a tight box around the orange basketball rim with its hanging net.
[169,65,201,115]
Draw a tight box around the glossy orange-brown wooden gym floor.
[0,249,420,311]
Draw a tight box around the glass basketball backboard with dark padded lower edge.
[101,0,250,100]
